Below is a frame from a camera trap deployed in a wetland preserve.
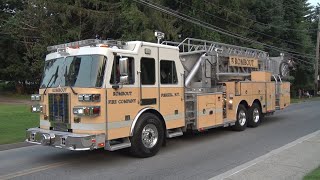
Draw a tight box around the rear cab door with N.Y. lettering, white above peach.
[159,48,185,129]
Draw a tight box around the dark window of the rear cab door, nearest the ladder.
[160,60,178,84]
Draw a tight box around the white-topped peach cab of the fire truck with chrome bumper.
[27,40,185,155]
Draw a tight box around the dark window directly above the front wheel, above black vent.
[140,58,156,85]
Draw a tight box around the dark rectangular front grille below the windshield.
[49,94,69,126]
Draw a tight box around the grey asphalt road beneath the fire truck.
[0,101,320,180]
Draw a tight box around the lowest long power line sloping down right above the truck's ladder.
[133,0,314,61]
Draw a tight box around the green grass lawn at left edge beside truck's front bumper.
[0,104,39,144]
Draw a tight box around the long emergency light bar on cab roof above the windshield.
[47,39,126,52]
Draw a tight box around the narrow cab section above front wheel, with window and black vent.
[139,46,159,110]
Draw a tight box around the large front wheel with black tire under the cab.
[130,113,164,158]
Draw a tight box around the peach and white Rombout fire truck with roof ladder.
[26,38,290,157]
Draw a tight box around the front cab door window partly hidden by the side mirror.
[110,56,134,84]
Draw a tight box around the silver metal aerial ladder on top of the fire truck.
[162,38,272,79]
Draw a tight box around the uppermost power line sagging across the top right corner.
[204,0,317,33]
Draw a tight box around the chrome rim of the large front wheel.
[141,124,158,148]
